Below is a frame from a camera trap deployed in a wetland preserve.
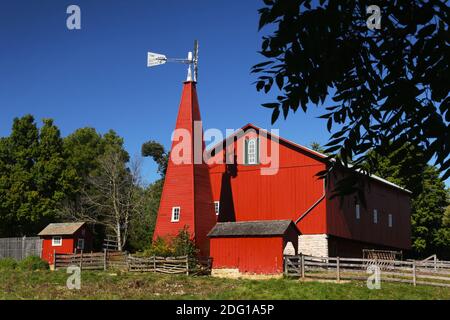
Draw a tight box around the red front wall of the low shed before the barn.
[210,236,283,274]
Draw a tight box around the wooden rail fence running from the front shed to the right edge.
[284,255,450,287]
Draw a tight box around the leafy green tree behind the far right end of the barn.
[369,144,450,258]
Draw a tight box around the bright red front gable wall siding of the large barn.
[210,126,326,233]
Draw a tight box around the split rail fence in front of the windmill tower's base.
[54,250,211,275]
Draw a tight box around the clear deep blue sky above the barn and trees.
[0,0,442,188]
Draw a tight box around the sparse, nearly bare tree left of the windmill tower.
[64,152,143,251]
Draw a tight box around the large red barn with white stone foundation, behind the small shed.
[210,124,411,257]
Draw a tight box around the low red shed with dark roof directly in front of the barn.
[208,220,300,274]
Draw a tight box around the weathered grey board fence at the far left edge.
[0,237,42,260]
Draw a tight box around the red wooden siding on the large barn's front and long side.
[210,125,411,249]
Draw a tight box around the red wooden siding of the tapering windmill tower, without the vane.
[153,82,216,255]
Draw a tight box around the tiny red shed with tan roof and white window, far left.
[38,222,93,264]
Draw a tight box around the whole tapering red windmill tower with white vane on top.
[147,41,216,256]
